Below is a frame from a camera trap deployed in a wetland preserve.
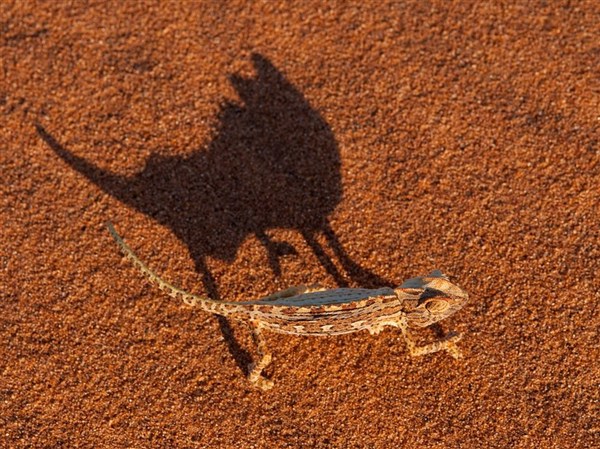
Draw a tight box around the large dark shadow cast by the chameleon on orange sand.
[41,54,390,291]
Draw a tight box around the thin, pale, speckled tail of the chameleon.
[106,223,229,315]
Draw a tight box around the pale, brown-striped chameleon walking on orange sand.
[107,223,468,390]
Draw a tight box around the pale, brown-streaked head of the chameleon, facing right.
[396,270,469,327]
